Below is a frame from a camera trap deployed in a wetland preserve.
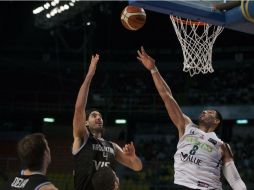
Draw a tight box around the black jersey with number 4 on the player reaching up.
[74,135,116,190]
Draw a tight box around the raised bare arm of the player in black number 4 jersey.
[73,54,99,151]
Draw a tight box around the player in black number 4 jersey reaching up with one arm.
[72,54,142,190]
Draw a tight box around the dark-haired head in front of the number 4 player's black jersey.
[92,167,116,190]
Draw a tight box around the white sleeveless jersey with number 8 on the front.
[174,123,223,190]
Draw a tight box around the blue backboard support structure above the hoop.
[129,0,254,34]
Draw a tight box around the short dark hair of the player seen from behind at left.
[17,133,47,171]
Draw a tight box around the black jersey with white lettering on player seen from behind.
[4,174,51,190]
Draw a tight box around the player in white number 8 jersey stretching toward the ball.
[137,47,246,190]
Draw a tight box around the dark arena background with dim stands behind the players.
[0,1,254,190]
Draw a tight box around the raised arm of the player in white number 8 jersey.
[137,47,191,138]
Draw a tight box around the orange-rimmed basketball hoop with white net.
[170,15,224,77]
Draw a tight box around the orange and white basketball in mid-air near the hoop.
[121,5,146,31]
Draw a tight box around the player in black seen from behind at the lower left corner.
[4,133,58,190]
